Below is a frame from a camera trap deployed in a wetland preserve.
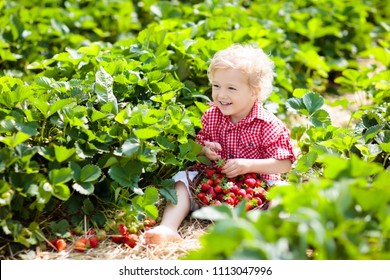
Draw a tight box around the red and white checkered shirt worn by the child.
[196,103,296,180]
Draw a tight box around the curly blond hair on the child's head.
[207,44,274,102]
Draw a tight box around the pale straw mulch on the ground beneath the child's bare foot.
[17,217,211,260]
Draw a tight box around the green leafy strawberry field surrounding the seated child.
[0,0,390,260]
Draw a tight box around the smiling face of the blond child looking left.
[212,69,256,123]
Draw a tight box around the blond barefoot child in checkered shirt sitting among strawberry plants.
[144,44,296,244]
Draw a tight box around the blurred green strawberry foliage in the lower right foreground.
[185,155,390,259]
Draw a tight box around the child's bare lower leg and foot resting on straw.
[144,181,191,244]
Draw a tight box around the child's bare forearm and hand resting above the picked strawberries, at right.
[222,158,292,178]
